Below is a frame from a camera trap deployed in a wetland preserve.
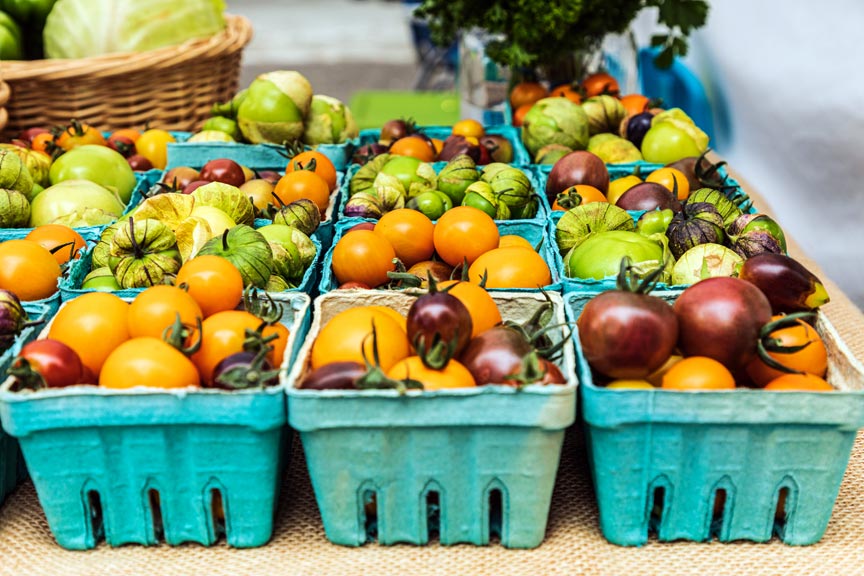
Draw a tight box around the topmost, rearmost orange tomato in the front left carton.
[174,255,243,318]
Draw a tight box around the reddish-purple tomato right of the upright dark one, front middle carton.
[459,326,534,386]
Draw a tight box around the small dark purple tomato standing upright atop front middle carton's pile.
[407,291,474,368]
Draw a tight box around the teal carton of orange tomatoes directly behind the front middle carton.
[318,218,562,294]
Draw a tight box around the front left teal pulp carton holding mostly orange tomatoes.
[0,294,310,549]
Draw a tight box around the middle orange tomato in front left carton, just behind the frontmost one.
[128,285,204,339]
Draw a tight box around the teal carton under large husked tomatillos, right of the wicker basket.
[166,132,359,171]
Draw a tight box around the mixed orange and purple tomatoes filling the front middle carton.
[301,281,566,391]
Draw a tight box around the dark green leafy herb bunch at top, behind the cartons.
[415,0,708,69]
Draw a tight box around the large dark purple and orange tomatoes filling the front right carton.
[578,278,833,391]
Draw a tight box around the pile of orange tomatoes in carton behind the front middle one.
[332,206,552,289]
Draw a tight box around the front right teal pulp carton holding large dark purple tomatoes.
[565,291,864,546]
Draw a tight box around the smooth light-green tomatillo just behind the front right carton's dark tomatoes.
[564,230,664,280]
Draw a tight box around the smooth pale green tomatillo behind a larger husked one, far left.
[48,144,137,204]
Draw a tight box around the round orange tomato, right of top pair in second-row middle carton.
[432,206,500,266]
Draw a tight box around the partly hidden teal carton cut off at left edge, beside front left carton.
[0,294,60,504]
